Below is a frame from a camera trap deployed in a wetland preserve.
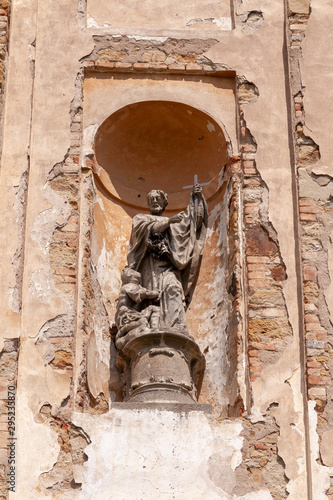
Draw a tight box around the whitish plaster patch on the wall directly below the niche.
[74,409,245,500]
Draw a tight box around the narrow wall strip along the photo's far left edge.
[0,0,29,499]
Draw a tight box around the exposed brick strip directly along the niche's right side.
[233,78,292,499]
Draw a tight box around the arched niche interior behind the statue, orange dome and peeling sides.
[91,101,230,414]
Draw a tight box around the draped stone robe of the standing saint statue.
[127,195,208,331]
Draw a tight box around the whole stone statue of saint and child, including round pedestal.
[115,184,208,403]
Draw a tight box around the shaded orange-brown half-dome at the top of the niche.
[95,101,227,210]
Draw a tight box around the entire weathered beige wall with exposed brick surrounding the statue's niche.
[0,0,333,500]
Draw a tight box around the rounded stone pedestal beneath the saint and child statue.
[117,329,205,404]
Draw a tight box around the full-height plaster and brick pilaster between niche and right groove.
[206,1,307,498]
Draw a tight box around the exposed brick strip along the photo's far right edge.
[287,2,333,492]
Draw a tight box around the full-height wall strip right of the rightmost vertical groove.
[288,0,333,499]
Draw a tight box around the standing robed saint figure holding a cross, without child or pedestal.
[116,184,207,340]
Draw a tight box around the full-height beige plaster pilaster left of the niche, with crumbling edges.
[0,1,92,498]
